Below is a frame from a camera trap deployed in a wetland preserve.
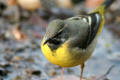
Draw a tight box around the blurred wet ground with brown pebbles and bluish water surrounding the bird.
[0,0,120,80]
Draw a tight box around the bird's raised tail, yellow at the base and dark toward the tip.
[91,0,115,15]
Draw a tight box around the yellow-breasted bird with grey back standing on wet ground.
[41,0,114,80]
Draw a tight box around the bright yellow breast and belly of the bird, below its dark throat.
[41,39,94,67]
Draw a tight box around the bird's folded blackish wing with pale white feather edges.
[69,13,101,49]
